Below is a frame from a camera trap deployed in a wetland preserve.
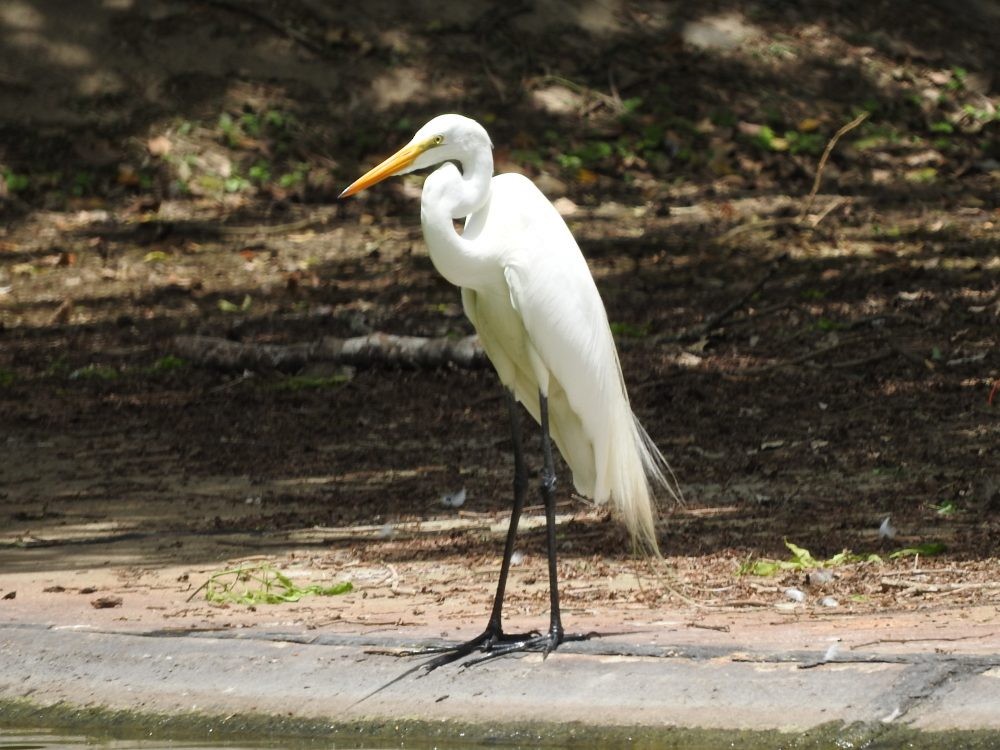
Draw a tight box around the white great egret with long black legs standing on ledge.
[341,114,676,669]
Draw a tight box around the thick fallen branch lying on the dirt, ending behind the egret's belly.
[173,333,487,372]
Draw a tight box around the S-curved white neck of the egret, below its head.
[420,149,502,289]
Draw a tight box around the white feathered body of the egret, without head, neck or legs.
[446,174,663,549]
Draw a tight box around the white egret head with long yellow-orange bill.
[340,115,493,198]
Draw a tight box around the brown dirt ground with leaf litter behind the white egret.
[0,0,1000,647]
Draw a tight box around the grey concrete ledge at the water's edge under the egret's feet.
[0,625,1000,747]
